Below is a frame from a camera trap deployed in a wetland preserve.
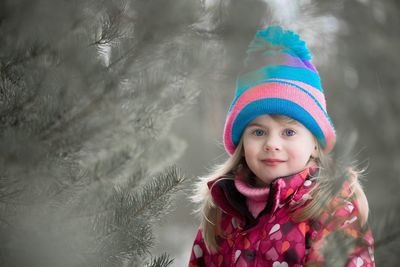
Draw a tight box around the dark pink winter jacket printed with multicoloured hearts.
[189,169,375,267]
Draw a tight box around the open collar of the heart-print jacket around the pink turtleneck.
[207,165,317,222]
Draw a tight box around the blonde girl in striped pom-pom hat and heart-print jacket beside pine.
[189,26,375,267]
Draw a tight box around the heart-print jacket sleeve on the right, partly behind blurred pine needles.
[306,192,375,267]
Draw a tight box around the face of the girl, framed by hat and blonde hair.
[242,115,318,185]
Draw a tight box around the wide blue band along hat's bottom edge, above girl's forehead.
[232,98,326,147]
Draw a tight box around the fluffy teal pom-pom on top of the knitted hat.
[247,26,312,60]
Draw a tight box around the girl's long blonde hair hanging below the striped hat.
[192,115,369,253]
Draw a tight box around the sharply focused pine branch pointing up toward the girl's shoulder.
[73,167,184,262]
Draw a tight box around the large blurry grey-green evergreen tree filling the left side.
[0,0,211,266]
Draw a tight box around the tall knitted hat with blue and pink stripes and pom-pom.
[224,26,336,154]
